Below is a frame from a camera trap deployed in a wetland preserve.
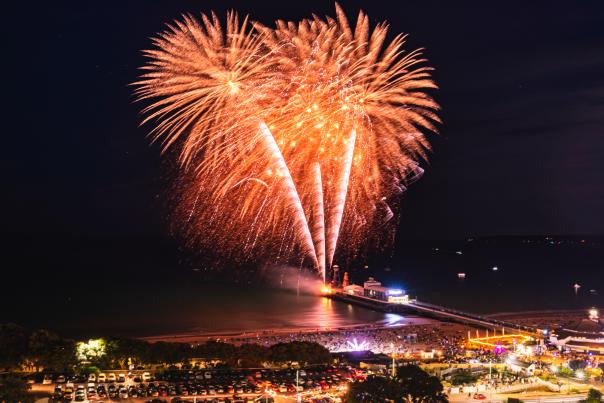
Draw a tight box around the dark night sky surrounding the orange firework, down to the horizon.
[2,0,604,240]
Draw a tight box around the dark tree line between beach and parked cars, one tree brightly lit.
[0,324,330,372]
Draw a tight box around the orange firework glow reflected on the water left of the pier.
[35,285,425,337]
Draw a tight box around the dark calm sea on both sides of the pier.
[0,237,604,336]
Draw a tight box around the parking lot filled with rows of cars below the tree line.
[33,366,364,403]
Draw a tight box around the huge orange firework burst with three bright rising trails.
[135,4,439,278]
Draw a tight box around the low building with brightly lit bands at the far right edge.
[549,309,604,355]
